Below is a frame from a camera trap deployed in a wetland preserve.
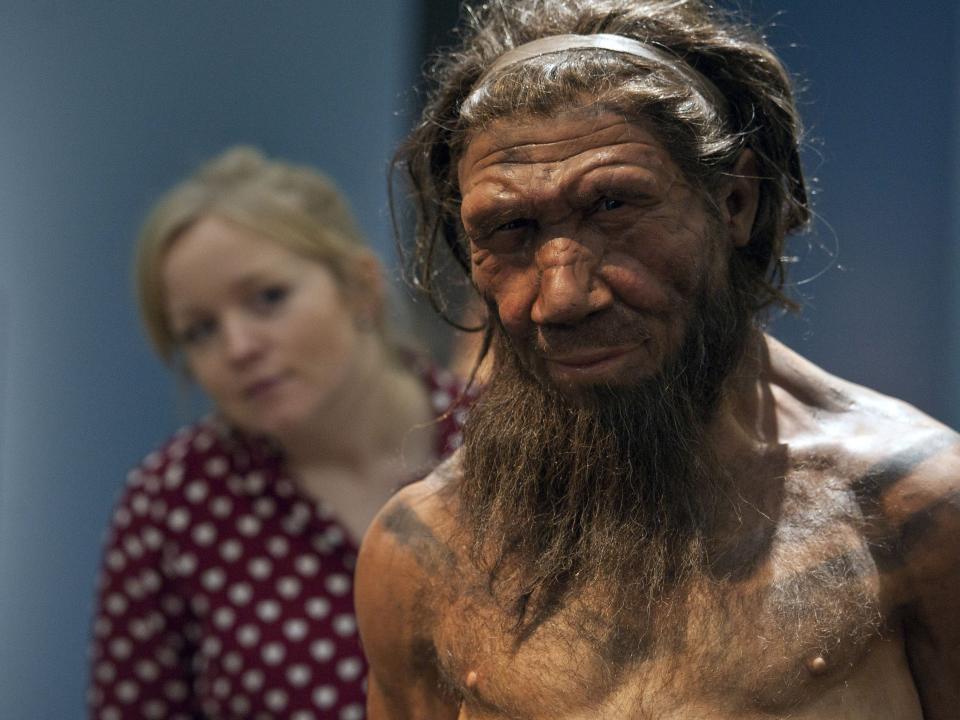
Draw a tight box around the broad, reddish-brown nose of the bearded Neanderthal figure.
[530,237,613,325]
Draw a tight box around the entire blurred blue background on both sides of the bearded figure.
[0,0,960,719]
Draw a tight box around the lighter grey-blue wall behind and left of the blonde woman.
[0,0,417,720]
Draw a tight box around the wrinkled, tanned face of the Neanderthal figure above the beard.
[458,110,752,391]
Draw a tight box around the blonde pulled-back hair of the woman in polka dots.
[134,146,383,364]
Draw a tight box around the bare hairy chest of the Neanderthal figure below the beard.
[436,500,909,720]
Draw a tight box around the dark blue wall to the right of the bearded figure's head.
[747,0,960,427]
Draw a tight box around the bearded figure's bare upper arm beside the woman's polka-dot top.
[355,483,459,720]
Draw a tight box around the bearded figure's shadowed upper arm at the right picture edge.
[891,438,960,718]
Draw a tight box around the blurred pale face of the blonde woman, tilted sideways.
[162,217,370,444]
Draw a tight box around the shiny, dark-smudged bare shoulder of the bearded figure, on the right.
[768,332,960,580]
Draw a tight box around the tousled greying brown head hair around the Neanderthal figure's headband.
[392,0,810,331]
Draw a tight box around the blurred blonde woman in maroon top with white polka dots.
[90,148,463,720]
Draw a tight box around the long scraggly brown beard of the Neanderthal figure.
[458,278,751,640]
